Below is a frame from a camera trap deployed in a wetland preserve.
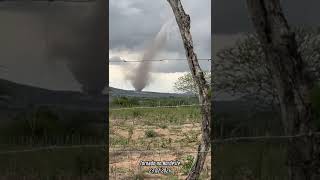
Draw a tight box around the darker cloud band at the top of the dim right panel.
[212,0,320,34]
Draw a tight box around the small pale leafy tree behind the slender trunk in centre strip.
[174,72,211,94]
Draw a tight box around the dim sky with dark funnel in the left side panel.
[0,0,107,93]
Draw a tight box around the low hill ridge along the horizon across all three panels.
[0,79,268,112]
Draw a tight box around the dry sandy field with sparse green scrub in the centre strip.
[109,107,211,179]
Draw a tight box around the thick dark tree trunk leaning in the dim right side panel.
[247,0,319,180]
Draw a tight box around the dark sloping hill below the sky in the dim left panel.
[0,79,108,110]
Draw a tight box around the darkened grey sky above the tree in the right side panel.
[212,0,320,100]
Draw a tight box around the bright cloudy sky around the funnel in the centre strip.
[109,0,211,92]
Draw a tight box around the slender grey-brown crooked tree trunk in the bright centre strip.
[167,0,211,179]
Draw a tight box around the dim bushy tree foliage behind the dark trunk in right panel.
[213,27,320,105]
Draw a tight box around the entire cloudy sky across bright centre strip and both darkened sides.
[0,0,320,92]
